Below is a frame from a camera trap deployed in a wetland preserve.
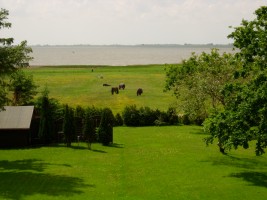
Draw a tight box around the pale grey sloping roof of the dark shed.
[0,106,34,129]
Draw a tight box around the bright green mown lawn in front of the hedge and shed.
[0,126,267,200]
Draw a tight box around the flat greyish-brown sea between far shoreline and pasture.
[30,44,237,67]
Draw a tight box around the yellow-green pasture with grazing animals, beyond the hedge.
[25,65,175,114]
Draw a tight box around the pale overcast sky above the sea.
[0,0,267,45]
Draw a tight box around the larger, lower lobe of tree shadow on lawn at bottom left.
[0,172,94,200]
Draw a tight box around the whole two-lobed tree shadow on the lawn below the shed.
[0,159,95,200]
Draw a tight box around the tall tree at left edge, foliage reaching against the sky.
[0,8,32,109]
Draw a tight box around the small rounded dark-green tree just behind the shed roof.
[9,70,37,105]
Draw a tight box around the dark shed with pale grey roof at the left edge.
[0,106,34,148]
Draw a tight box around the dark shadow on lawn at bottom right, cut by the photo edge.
[230,172,267,188]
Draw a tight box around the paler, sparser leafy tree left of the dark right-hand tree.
[165,49,240,123]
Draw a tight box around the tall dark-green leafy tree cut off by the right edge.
[204,6,267,155]
